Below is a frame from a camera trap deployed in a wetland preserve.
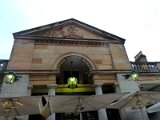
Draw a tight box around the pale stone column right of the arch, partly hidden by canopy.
[95,83,108,120]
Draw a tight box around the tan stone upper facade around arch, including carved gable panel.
[8,25,130,70]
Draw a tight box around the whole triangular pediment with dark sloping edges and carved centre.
[14,19,124,41]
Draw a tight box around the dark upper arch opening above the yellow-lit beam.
[56,55,93,84]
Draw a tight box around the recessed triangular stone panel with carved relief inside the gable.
[29,24,104,39]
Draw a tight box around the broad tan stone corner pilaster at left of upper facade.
[7,39,34,70]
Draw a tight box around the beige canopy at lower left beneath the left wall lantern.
[0,96,41,117]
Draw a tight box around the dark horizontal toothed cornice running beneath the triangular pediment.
[14,36,124,46]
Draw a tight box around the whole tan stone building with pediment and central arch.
[1,19,160,120]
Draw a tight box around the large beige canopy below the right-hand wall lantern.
[109,91,160,109]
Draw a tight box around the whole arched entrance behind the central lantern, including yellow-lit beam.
[56,55,98,120]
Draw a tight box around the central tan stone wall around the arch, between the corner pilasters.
[32,45,112,69]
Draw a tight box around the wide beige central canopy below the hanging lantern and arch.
[42,93,127,116]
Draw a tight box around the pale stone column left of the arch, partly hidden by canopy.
[47,84,57,120]
